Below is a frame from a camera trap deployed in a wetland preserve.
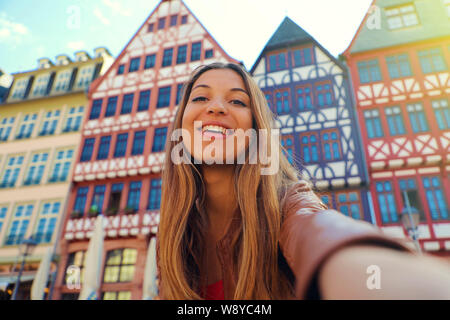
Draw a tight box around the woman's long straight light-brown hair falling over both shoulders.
[158,63,316,299]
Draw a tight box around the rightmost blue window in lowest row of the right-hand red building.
[422,177,449,220]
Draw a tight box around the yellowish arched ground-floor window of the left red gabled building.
[103,248,137,283]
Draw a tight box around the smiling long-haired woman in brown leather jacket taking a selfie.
[157,63,450,299]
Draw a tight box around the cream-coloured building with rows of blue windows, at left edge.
[0,48,114,299]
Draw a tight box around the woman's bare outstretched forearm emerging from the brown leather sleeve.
[318,245,450,300]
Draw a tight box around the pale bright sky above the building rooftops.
[0,0,372,73]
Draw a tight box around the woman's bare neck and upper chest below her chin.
[202,165,237,239]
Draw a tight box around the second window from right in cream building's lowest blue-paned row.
[5,204,34,246]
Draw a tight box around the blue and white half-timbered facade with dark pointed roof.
[251,17,374,223]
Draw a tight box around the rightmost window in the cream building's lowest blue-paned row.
[34,201,61,243]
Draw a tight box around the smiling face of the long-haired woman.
[182,69,253,164]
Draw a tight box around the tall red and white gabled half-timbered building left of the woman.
[52,0,237,299]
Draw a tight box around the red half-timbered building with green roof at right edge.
[344,0,450,256]
